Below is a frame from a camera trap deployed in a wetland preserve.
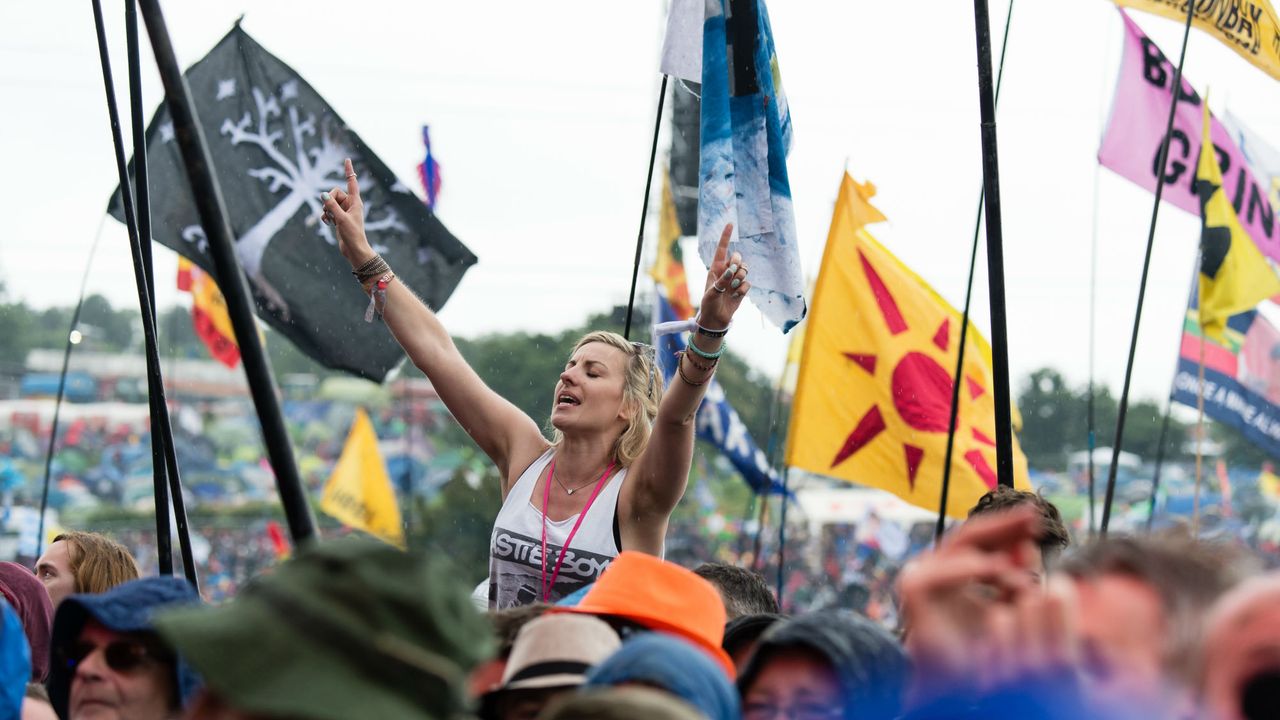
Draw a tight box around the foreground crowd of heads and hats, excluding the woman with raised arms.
[0,488,1280,720]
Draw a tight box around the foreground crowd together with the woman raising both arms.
[0,161,1280,720]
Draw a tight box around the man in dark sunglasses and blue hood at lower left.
[49,578,200,720]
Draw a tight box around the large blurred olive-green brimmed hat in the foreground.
[155,538,492,720]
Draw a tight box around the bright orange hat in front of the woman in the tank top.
[548,551,737,679]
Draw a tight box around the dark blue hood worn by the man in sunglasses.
[47,577,200,717]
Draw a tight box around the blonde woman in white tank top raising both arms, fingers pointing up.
[321,160,751,610]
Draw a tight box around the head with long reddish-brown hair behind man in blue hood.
[36,532,138,609]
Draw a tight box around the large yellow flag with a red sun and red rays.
[787,174,1028,518]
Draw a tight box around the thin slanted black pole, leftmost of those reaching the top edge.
[93,0,200,592]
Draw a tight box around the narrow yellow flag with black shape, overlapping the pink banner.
[1196,100,1280,340]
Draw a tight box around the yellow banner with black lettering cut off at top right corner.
[1115,0,1280,79]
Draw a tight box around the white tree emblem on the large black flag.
[209,83,410,318]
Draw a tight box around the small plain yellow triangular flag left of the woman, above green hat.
[320,409,404,547]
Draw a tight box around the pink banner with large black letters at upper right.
[1098,13,1280,261]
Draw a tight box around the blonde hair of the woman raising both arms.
[552,331,662,468]
